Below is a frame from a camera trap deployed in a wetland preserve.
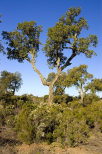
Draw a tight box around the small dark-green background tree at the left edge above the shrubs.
[0,71,22,95]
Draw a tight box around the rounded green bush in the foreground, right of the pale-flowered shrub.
[54,108,89,146]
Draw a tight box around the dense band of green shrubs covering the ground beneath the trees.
[0,95,102,146]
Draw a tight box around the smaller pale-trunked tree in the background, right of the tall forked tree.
[66,65,93,103]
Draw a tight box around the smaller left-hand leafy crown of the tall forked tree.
[2,21,42,62]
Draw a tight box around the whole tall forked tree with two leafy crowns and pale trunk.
[3,8,97,105]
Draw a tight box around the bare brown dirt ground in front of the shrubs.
[0,128,102,154]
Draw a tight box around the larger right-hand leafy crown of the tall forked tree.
[44,8,97,68]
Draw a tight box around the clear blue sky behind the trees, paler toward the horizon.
[0,0,102,96]
